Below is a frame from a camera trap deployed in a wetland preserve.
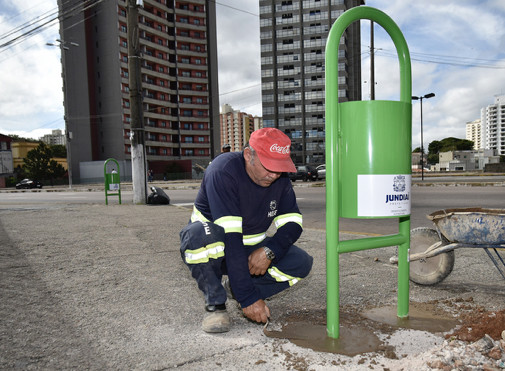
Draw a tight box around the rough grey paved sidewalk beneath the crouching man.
[0,205,505,370]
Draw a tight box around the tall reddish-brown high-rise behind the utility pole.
[58,0,220,182]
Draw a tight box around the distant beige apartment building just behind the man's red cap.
[220,104,262,151]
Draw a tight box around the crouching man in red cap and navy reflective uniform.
[180,128,312,333]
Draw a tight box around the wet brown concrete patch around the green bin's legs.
[264,303,459,359]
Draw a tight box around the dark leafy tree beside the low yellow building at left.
[24,142,65,185]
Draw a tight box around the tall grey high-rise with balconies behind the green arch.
[260,0,364,164]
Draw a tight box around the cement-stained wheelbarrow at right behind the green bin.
[390,208,505,285]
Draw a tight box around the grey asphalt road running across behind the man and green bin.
[0,184,505,234]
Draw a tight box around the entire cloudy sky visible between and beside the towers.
[0,0,505,149]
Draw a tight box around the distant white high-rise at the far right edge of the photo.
[480,95,505,155]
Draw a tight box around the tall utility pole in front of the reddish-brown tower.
[127,0,147,204]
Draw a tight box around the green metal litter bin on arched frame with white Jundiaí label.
[325,6,412,338]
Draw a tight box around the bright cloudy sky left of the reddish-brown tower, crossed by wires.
[0,0,64,139]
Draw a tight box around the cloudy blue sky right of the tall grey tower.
[362,0,505,148]
